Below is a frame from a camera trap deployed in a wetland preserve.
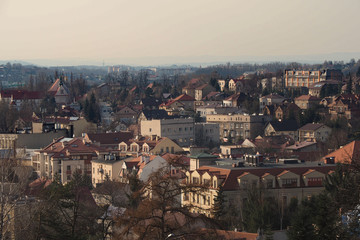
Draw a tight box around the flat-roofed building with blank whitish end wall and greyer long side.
[141,118,195,147]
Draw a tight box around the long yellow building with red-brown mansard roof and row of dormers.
[181,164,336,217]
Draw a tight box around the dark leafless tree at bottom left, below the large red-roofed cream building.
[37,171,101,239]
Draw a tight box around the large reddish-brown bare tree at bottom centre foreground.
[117,167,215,239]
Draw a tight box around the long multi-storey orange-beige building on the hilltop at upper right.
[285,69,343,88]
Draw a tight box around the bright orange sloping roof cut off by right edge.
[322,140,360,164]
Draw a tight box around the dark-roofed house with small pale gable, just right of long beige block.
[264,120,299,139]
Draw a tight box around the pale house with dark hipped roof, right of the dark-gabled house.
[299,123,331,142]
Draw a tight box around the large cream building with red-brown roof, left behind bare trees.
[31,138,107,183]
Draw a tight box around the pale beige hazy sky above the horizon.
[0,0,360,64]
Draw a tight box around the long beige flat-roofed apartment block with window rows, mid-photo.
[206,114,272,142]
